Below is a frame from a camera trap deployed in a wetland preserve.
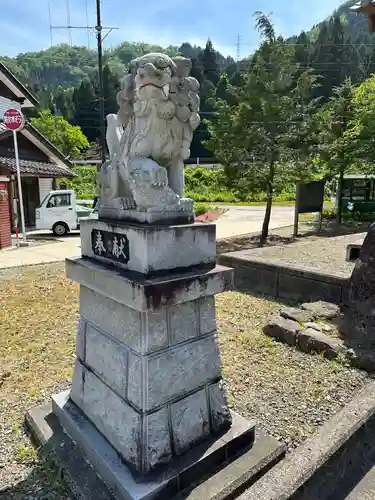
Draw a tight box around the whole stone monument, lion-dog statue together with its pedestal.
[26,53,279,500]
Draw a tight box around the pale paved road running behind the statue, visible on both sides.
[0,206,294,269]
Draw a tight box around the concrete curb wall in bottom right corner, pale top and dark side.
[238,382,375,500]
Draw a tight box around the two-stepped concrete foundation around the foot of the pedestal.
[26,395,285,500]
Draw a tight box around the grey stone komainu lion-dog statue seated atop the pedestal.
[99,53,200,222]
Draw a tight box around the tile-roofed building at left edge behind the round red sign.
[0,62,75,244]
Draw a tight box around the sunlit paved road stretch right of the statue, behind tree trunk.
[216,205,294,238]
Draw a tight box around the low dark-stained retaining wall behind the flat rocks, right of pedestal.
[219,250,349,304]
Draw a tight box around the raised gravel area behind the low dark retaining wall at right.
[234,233,366,276]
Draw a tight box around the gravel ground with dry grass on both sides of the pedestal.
[0,263,369,500]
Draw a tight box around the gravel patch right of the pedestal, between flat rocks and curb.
[217,292,370,450]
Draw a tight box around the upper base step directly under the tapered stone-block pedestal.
[52,392,255,500]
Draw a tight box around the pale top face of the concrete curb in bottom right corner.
[238,382,375,500]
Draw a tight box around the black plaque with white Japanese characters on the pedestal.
[91,229,130,264]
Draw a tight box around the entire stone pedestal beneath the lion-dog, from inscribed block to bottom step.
[47,219,262,499]
